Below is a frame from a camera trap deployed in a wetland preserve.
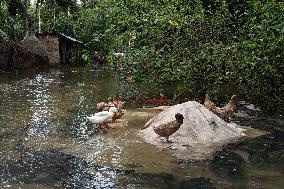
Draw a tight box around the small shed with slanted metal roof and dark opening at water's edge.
[36,33,83,65]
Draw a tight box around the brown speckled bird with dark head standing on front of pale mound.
[153,113,184,142]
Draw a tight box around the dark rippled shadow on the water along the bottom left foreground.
[0,144,214,189]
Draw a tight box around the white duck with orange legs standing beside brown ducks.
[87,107,118,129]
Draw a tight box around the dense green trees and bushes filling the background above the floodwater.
[0,0,284,110]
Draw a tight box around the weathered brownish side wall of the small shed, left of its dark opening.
[38,35,60,65]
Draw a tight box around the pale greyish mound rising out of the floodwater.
[141,101,244,159]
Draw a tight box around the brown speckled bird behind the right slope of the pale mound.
[204,95,238,122]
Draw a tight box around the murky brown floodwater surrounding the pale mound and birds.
[0,67,284,189]
